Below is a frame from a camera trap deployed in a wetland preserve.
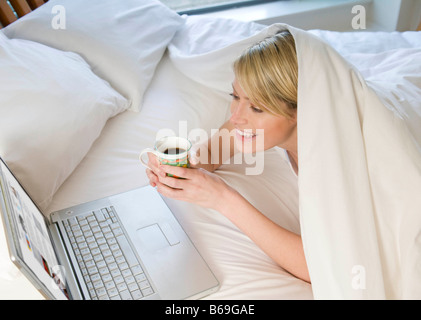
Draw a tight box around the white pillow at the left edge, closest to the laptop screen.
[0,32,128,210]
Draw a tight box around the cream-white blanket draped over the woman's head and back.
[169,24,421,299]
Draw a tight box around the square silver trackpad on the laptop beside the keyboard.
[136,223,180,251]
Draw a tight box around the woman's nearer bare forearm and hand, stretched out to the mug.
[146,146,310,282]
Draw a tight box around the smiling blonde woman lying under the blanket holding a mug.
[147,31,310,282]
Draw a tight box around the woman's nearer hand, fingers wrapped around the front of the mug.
[155,165,235,212]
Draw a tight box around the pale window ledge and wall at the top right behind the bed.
[200,0,421,31]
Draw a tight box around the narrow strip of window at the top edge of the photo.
[160,0,279,14]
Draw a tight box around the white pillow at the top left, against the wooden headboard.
[4,0,184,111]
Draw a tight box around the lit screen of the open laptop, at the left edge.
[0,159,68,299]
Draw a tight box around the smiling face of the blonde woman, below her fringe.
[230,80,297,153]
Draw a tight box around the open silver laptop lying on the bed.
[0,158,219,300]
